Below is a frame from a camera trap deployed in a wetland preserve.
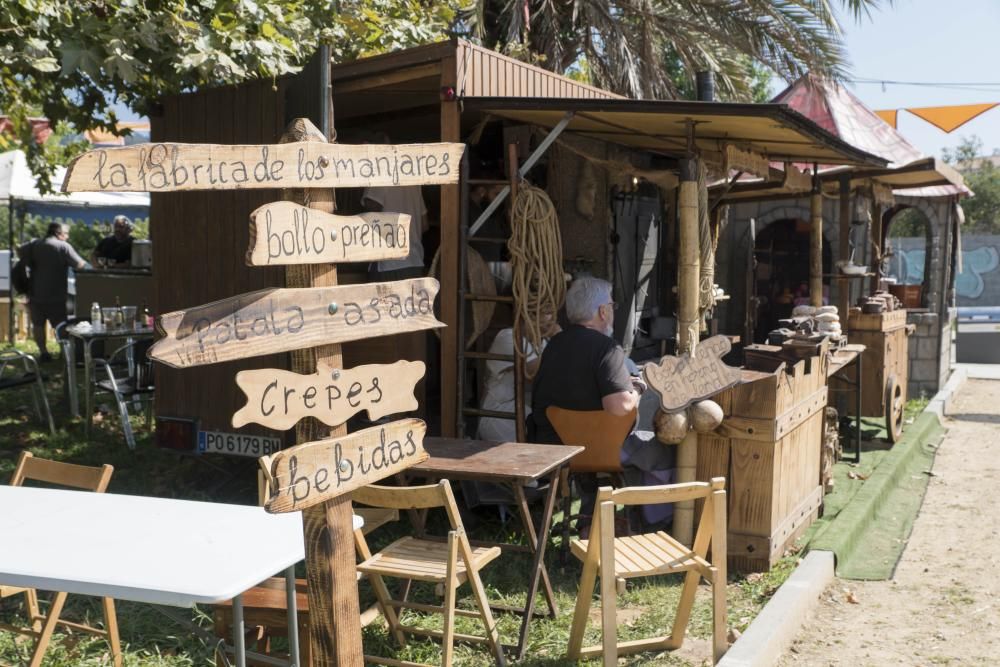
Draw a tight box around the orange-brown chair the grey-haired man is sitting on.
[545,405,639,544]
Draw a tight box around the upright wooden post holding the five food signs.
[281,118,364,667]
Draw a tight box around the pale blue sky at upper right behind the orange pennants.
[828,0,1000,157]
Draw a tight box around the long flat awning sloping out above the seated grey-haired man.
[463,97,887,167]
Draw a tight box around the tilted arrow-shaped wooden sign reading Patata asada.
[150,278,444,368]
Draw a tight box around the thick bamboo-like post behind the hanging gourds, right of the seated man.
[673,153,701,546]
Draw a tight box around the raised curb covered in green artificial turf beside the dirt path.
[809,411,944,560]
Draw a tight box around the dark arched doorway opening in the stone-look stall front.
[750,218,832,342]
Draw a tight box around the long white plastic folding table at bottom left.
[0,486,362,667]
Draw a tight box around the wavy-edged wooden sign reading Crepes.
[233,361,425,431]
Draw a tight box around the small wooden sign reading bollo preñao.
[247,201,410,266]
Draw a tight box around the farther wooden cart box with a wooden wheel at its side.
[830,310,910,417]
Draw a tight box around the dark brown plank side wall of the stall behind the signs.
[150,80,288,435]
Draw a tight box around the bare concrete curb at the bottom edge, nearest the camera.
[718,551,834,667]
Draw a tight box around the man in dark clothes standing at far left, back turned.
[17,222,87,362]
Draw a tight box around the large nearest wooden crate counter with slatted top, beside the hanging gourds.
[697,357,827,572]
